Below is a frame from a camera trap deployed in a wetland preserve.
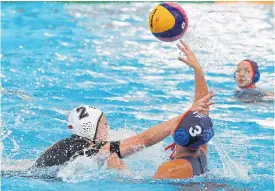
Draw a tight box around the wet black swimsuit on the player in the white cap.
[35,135,107,167]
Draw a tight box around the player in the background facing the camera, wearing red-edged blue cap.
[234,59,274,102]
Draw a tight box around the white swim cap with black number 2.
[67,105,103,141]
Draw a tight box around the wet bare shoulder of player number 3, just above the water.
[153,159,193,179]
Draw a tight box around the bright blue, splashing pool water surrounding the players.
[0,2,275,191]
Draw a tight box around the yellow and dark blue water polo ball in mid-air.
[149,2,188,42]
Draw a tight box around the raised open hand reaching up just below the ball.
[177,40,201,69]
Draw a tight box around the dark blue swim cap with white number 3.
[174,111,214,149]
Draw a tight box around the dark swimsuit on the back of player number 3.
[176,151,208,176]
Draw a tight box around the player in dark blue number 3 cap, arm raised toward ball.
[108,41,217,179]
